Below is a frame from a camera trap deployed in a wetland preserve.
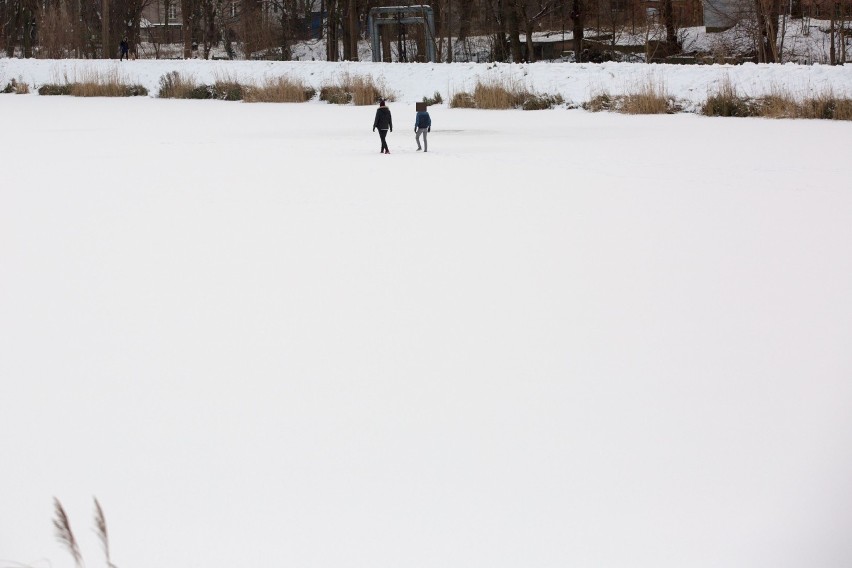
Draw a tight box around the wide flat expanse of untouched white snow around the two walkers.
[5,60,852,568]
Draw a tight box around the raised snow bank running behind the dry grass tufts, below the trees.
[5,59,852,109]
